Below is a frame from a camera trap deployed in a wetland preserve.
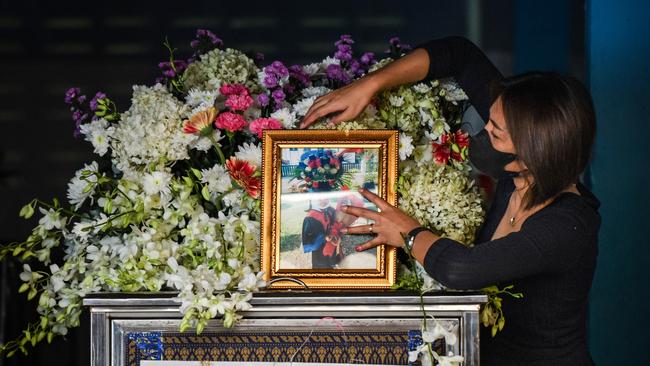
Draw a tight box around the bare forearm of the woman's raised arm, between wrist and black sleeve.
[366,48,429,92]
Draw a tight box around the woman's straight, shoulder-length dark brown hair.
[495,72,596,208]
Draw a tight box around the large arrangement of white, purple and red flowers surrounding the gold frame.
[0,30,498,364]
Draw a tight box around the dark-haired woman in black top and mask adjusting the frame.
[302,37,600,366]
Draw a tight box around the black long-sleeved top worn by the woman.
[420,37,600,366]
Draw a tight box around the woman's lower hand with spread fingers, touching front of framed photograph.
[342,189,421,252]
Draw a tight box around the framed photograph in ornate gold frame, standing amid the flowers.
[260,130,399,289]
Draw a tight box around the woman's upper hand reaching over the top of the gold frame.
[300,74,381,128]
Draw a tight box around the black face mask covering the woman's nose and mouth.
[469,129,519,179]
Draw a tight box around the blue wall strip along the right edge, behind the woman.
[585,0,650,365]
